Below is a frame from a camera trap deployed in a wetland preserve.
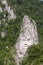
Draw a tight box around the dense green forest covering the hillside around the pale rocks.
[0,0,43,65]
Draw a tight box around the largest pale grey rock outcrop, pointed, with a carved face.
[16,15,38,65]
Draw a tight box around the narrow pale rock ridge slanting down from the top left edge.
[1,0,16,19]
